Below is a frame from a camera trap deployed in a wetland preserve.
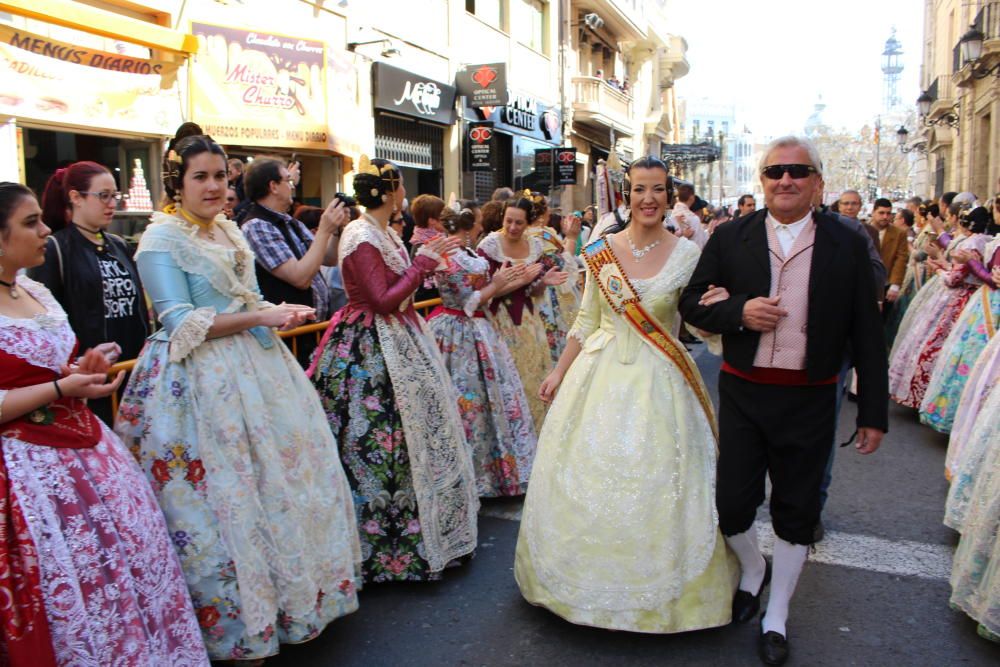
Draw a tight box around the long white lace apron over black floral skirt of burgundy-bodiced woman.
[375,315,479,572]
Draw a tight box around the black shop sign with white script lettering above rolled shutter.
[372,63,457,125]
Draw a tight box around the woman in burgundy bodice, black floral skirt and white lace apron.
[309,157,479,581]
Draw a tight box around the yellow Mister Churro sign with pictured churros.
[190,23,328,149]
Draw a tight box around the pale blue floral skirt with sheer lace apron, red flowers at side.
[116,332,360,660]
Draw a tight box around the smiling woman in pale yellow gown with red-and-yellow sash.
[514,158,738,633]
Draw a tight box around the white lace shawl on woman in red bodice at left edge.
[0,276,76,374]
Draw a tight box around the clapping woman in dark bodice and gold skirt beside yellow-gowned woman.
[477,198,568,429]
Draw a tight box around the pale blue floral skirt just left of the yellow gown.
[427,313,538,498]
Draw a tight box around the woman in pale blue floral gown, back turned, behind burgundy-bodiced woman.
[427,202,537,498]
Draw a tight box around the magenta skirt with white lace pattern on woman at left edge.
[0,428,208,667]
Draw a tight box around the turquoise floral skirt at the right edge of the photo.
[920,285,1000,433]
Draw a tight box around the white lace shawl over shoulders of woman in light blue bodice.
[135,217,264,313]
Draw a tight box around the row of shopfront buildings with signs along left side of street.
[0,0,689,215]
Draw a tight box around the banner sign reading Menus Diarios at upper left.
[0,26,183,135]
